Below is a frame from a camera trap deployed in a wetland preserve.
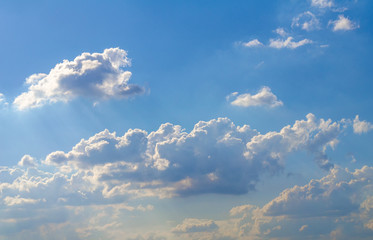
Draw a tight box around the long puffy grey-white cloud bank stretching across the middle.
[0,114,343,206]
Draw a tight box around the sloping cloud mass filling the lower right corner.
[186,166,373,240]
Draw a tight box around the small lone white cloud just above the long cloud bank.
[227,87,283,108]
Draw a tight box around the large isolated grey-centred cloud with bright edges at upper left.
[13,48,144,110]
